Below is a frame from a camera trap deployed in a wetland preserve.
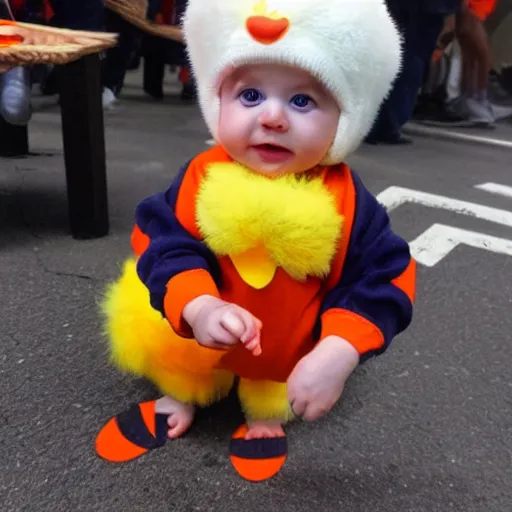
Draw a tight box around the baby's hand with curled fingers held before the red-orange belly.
[183,295,262,356]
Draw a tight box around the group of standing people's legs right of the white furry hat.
[367,0,512,144]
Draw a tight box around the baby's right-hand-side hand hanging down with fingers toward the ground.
[287,336,359,421]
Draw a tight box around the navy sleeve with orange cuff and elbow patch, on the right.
[321,173,416,360]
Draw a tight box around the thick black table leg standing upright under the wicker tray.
[58,55,109,239]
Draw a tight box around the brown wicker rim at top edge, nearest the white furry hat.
[105,0,183,42]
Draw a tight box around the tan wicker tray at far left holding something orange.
[0,23,117,66]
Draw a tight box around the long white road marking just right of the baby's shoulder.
[377,187,512,227]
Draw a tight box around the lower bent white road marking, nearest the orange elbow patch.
[410,224,512,267]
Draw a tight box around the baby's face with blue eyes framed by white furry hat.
[218,64,340,176]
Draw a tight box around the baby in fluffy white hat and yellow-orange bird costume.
[96,0,415,480]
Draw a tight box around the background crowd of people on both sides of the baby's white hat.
[0,0,512,144]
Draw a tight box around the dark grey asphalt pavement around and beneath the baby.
[0,75,512,512]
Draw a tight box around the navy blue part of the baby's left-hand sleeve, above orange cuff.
[135,166,221,316]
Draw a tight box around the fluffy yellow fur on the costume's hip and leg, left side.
[101,259,234,406]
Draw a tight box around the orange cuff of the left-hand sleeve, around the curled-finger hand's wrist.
[164,269,220,338]
